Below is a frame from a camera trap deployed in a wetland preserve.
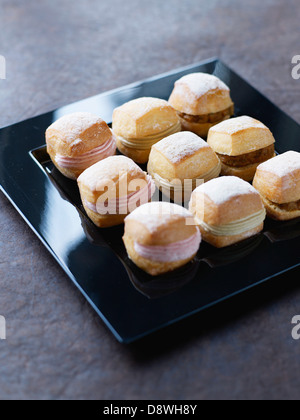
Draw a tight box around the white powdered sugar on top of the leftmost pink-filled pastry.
[49,112,103,144]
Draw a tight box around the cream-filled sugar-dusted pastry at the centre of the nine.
[148,131,221,203]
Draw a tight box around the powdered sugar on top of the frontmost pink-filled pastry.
[126,202,193,233]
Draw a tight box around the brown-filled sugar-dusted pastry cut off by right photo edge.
[253,151,300,220]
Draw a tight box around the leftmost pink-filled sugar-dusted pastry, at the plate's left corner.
[46,112,117,180]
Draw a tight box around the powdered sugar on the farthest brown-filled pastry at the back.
[176,73,229,98]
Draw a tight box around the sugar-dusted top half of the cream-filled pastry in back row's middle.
[113,98,179,139]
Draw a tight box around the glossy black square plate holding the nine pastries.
[0,59,300,343]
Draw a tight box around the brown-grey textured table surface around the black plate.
[0,0,300,399]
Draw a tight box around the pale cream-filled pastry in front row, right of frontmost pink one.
[190,176,266,248]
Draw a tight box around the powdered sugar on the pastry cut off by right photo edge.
[258,151,300,177]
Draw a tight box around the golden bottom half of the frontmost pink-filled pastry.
[123,235,196,276]
